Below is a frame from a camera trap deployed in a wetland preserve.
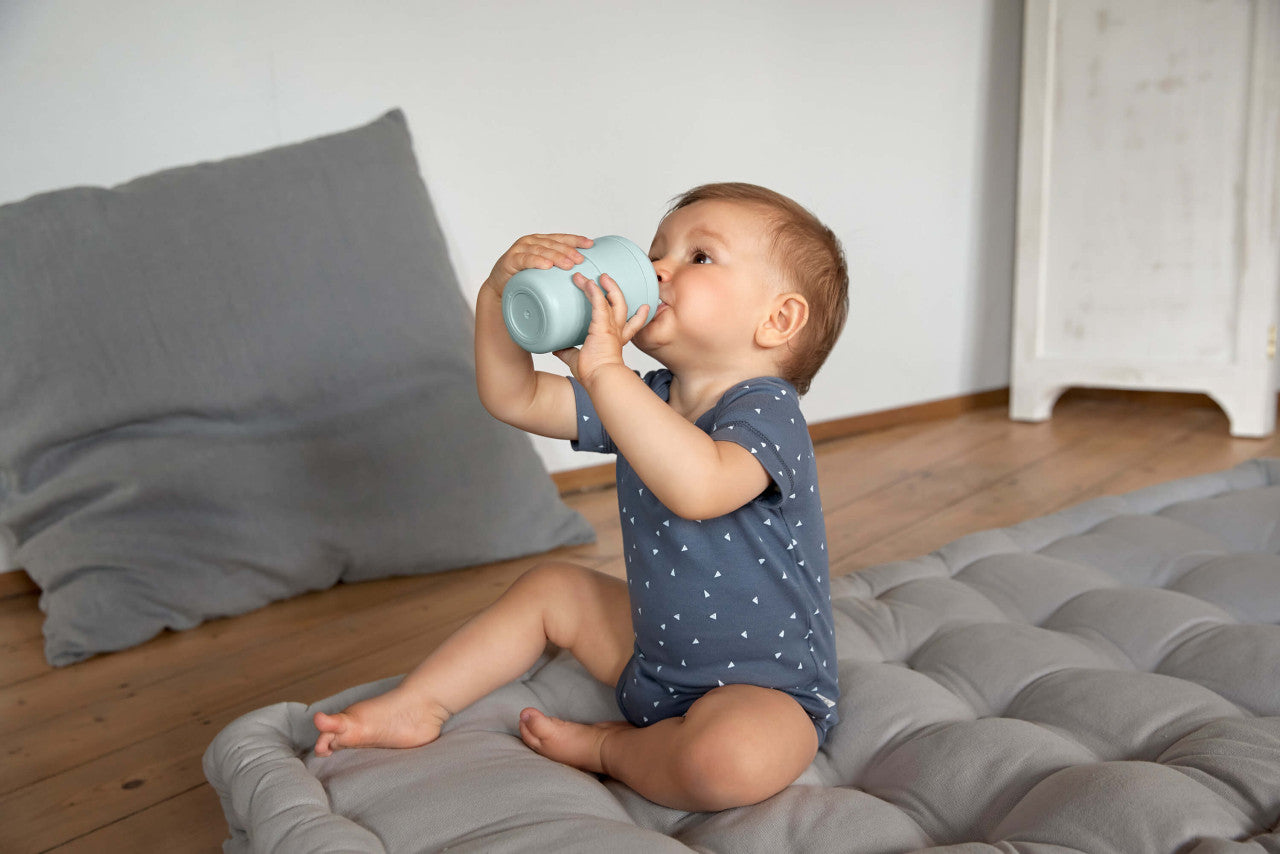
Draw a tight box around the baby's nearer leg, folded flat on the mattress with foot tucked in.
[520,685,818,810]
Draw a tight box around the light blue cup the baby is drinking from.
[502,234,658,353]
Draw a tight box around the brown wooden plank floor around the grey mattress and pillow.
[0,397,1280,853]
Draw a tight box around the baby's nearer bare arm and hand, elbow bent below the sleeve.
[556,275,772,519]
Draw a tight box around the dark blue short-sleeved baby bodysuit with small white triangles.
[572,369,840,744]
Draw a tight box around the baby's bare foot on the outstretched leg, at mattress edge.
[314,689,449,757]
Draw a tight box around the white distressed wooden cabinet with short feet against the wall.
[1010,0,1280,435]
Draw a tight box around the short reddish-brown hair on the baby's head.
[667,182,849,394]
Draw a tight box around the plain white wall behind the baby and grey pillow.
[0,0,1021,470]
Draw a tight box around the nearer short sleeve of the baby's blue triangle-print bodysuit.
[710,378,813,504]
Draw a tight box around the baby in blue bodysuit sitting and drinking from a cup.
[315,183,849,810]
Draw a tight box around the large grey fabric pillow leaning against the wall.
[0,110,593,665]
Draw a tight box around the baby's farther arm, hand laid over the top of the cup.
[475,234,591,439]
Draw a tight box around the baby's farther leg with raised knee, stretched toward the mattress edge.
[315,563,634,757]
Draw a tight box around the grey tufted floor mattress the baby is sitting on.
[205,460,1280,854]
